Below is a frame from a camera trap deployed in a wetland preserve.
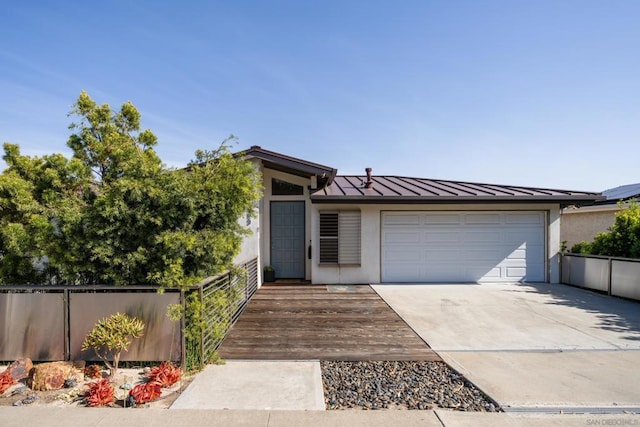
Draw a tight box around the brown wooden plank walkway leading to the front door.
[218,284,440,361]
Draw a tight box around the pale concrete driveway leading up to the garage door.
[373,284,640,412]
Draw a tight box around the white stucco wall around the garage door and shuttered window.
[310,203,560,284]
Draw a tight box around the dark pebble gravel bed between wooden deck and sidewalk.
[320,361,500,412]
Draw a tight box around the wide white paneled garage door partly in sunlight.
[382,212,545,283]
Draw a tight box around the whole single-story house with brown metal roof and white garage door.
[237,147,602,284]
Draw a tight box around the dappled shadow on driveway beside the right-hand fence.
[509,283,640,343]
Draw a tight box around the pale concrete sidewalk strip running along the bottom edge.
[0,407,640,427]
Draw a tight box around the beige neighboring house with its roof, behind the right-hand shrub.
[560,183,640,249]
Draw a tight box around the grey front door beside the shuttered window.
[271,201,305,279]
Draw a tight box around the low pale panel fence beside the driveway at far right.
[560,254,640,301]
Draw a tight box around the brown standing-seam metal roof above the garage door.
[311,175,604,204]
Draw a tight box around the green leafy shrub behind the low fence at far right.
[571,200,640,258]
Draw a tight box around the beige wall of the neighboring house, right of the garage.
[560,205,620,249]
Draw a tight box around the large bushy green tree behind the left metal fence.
[0,92,260,286]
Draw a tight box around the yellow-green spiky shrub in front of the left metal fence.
[82,313,144,379]
